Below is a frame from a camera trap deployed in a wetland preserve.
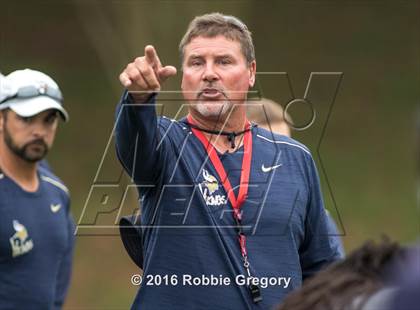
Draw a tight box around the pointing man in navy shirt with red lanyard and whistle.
[116,13,340,309]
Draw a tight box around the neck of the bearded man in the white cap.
[0,142,39,192]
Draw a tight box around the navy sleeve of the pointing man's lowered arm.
[299,155,342,280]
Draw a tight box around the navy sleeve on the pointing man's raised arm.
[115,91,166,185]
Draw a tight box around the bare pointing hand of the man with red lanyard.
[120,45,176,102]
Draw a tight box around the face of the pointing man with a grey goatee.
[181,35,256,118]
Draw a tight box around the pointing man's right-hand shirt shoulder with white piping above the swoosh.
[255,127,311,157]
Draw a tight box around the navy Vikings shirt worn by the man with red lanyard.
[116,94,340,309]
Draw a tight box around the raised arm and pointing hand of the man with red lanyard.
[115,45,176,184]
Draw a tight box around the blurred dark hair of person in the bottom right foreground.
[278,238,405,310]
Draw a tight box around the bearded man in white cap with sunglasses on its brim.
[0,69,74,309]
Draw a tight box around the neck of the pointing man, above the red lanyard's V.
[189,109,246,153]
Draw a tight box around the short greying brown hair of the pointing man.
[179,13,255,64]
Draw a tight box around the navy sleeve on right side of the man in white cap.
[54,205,75,309]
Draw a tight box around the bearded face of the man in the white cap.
[0,110,58,162]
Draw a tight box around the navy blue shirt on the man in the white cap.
[0,167,74,309]
